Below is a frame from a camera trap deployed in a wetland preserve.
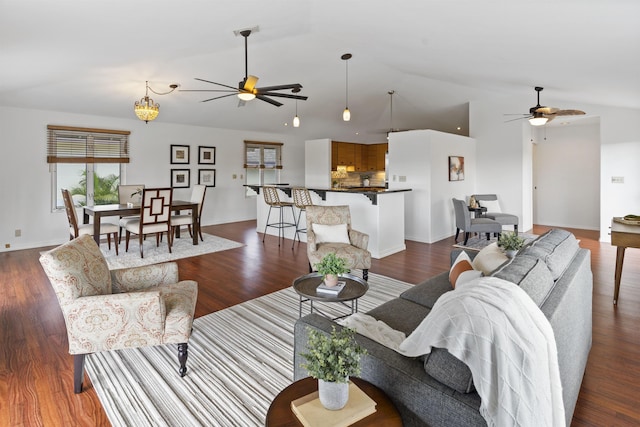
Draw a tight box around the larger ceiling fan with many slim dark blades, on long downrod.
[181,30,308,107]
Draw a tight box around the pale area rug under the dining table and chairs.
[100,232,244,270]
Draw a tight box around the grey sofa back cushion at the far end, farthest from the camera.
[520,229,580,280]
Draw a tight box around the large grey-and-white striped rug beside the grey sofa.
[86,273,411,427]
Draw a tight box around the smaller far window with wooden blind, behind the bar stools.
[244,141,282,196]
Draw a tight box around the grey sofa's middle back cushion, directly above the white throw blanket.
[491,255,555,307]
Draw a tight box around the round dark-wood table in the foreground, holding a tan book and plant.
[265,377,402,427]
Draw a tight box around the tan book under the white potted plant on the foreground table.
[291,382,376,427]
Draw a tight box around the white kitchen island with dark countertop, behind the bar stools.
[247,185,411,259]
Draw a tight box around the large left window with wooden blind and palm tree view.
[47,125,131,210]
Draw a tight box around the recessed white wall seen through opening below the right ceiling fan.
[533,122,600,230]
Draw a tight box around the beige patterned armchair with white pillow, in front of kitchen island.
[307,206,371,280]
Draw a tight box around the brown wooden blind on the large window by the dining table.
[47,125,131,163]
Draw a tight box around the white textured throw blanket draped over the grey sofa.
[399,277,565,427]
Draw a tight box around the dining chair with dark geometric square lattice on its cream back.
[125,188,173,258]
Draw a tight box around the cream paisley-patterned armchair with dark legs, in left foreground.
[40,235,198,393]
